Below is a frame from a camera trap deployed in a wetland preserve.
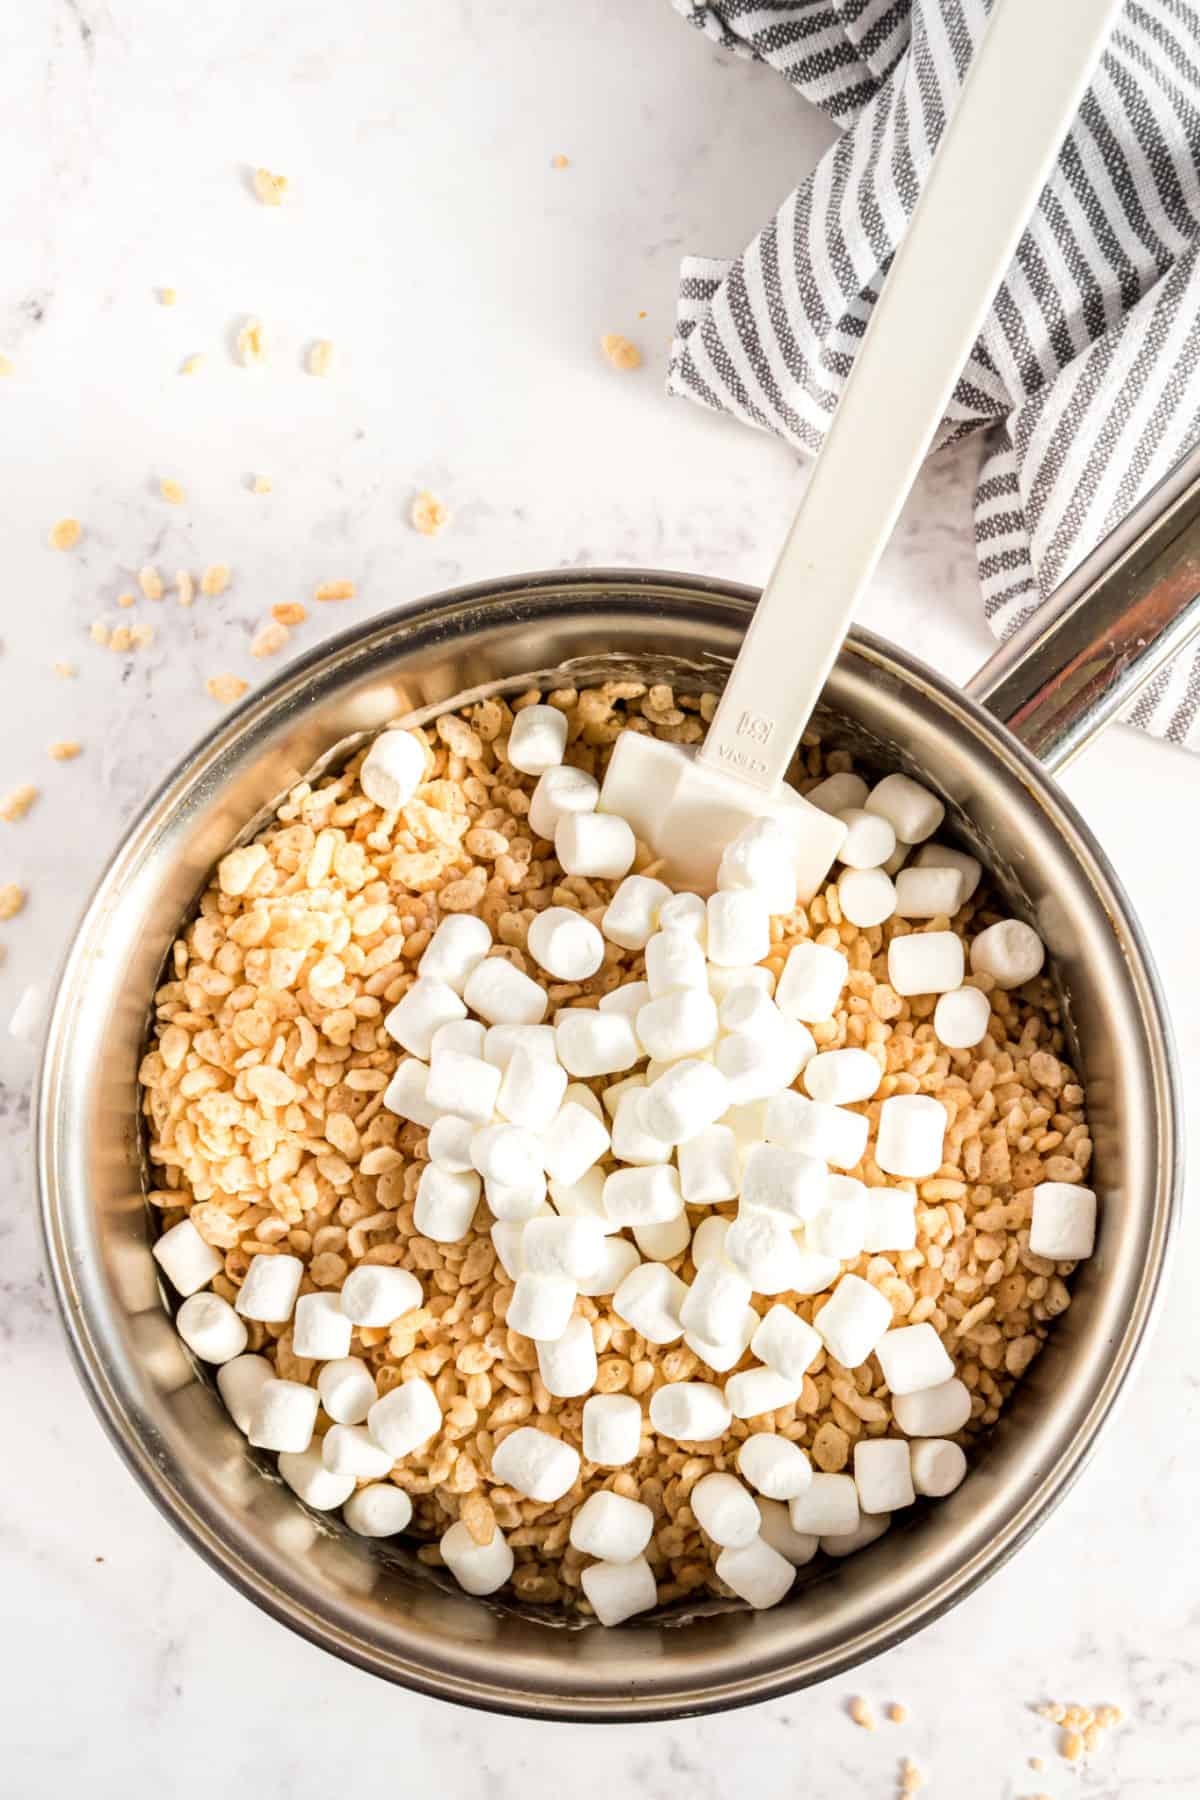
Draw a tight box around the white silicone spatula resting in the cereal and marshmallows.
[601,0,1121,900]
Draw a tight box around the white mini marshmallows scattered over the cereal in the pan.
[155,706,1096,1625]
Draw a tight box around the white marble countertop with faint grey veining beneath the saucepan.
[0,0,1200,1800]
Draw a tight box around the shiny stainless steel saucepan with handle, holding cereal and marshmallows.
[38,439,1200,1721]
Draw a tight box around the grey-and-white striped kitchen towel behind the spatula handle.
[667,0,1200,749]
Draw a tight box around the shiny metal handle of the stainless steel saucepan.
[966,446,1200,770]
